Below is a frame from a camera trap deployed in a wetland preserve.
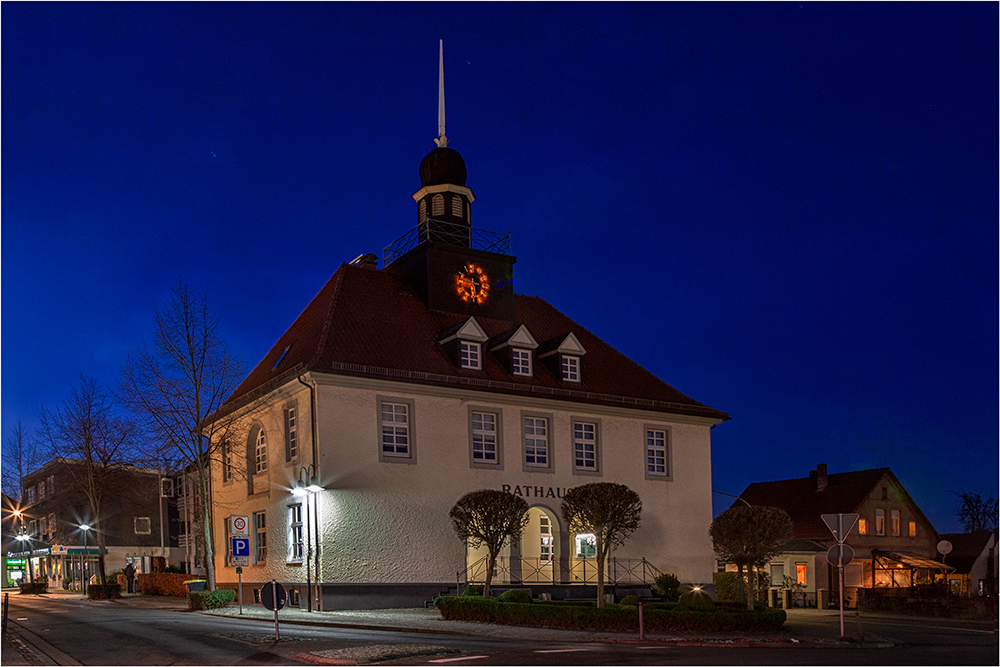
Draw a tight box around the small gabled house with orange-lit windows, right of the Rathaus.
[736,463,947,602]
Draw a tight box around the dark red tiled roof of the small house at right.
[734,468,902,540]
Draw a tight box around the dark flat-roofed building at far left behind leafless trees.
[21,458,182,587]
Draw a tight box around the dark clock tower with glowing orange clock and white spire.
[384,44,516,321]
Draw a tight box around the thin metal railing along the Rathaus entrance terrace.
[465,556,663,586]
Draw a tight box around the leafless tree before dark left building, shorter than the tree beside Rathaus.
[38,377,139,584]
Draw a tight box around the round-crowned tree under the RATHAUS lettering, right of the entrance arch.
[562,482,642,607]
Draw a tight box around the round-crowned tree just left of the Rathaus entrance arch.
[449,489,528,597]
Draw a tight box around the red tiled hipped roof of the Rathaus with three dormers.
[228,264,729,420]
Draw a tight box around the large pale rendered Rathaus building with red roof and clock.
[205,73,729,608]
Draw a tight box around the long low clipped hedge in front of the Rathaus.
[434,596,785,632]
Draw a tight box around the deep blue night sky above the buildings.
[0,2,998,532]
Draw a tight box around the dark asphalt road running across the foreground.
[3,596,998,667]
